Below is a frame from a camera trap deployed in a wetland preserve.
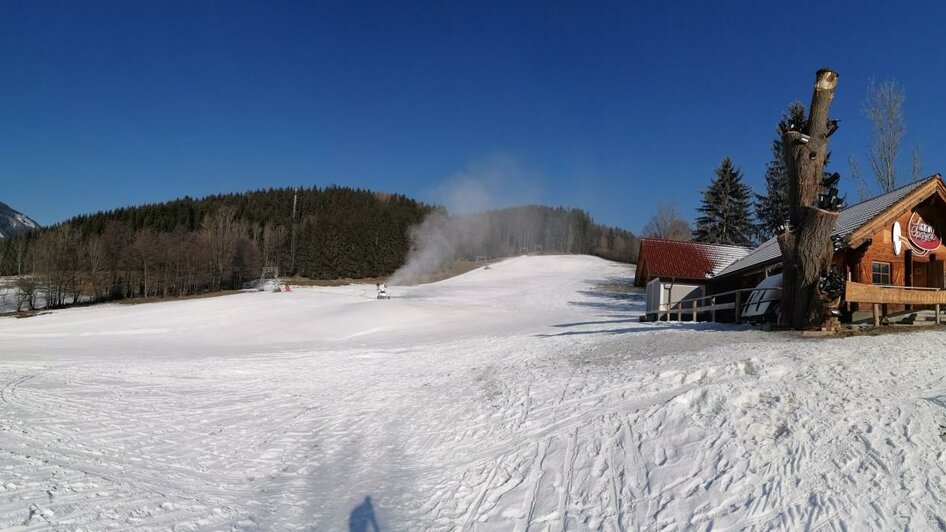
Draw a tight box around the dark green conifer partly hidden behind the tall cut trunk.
[754,101,805,240]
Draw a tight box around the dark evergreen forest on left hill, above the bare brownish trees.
[64,187,435,281]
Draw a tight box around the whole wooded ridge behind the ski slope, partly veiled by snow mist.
[0,187,637,306]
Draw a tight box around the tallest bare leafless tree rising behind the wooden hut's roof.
[864,79,907,192]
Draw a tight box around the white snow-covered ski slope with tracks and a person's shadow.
[0,256,946,530]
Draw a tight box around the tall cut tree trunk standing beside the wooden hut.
[778,69,838,329]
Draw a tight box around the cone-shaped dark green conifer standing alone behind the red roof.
[693,157,755,246]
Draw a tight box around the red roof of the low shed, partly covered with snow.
[634,238,751,286]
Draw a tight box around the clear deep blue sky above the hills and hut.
[0,1,946,231]
